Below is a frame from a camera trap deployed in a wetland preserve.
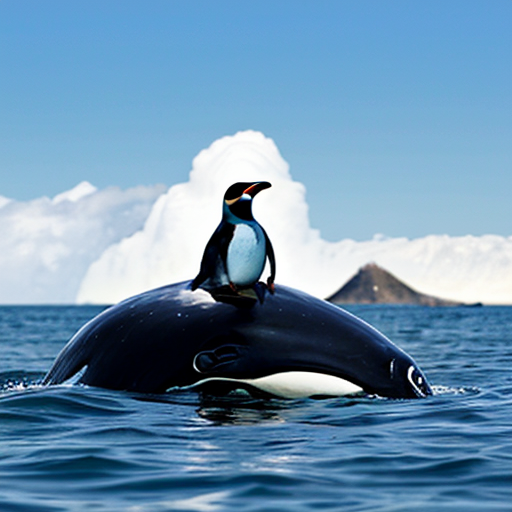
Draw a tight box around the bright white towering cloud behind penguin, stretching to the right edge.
[76,131,512,303]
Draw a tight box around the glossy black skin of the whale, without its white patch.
[43,281,432,398]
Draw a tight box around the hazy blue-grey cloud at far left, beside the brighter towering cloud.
[0,182,165,304]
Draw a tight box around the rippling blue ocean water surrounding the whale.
[0,305,512,512]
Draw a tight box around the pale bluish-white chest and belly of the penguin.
[226,224,266,286]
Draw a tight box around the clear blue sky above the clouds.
[0,0,512,240]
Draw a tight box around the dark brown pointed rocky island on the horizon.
[327,263,461,306]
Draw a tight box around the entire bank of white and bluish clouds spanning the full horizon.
[0,131,512,304]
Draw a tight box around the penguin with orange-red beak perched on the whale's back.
[191,181,276,302]
